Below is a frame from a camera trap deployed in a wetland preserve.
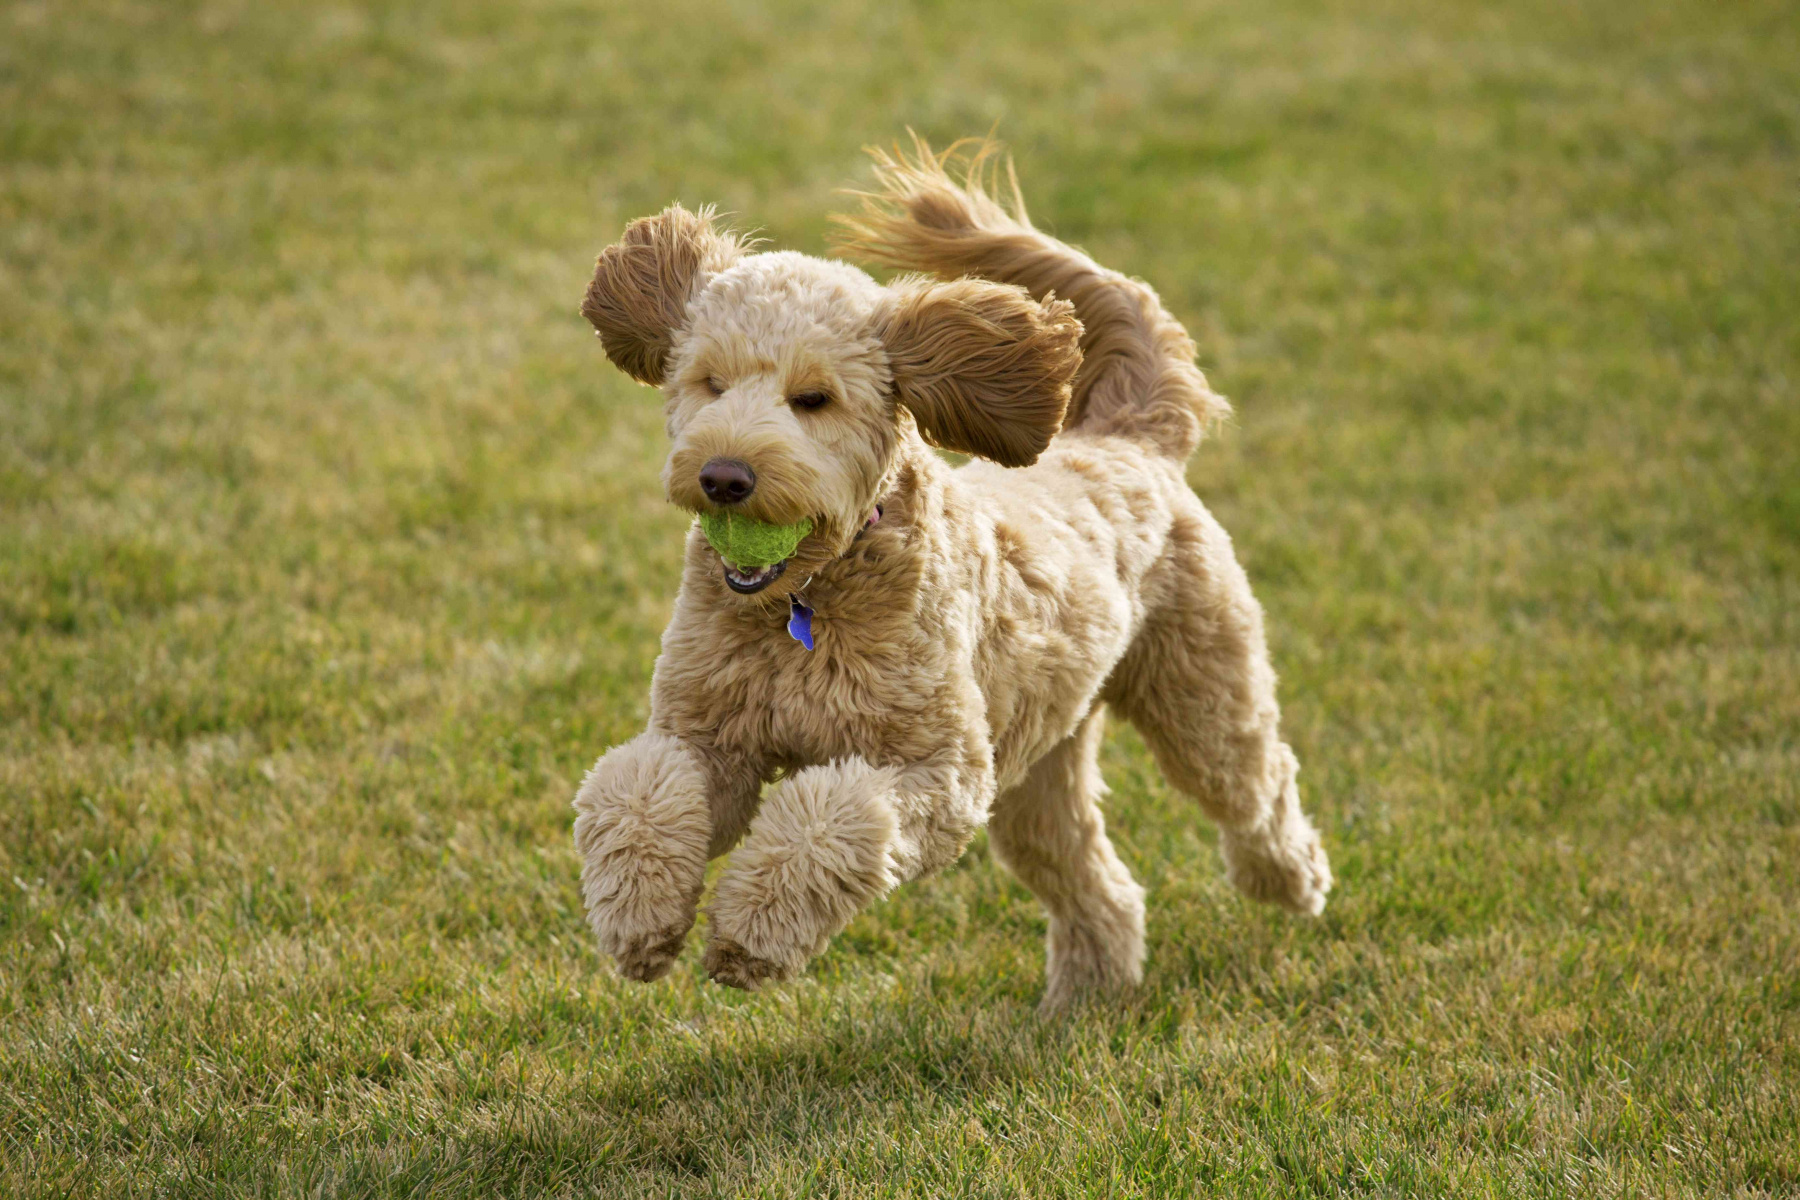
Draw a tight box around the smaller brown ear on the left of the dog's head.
[581,205,743,383]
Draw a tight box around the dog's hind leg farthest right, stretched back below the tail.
[1105,500,1332,916]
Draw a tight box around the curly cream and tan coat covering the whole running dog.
[576,134,1330,1009]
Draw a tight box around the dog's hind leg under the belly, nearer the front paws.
[988,703,1143,1013]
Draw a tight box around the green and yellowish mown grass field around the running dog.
[0,0,1800,1196]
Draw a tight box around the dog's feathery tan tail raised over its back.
[833,133,1231,459]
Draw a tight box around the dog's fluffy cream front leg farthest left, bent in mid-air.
[574,732,760,982]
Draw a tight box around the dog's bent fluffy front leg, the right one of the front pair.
[706,757,992,990]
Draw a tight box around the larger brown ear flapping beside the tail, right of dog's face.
[875,279,1082,466]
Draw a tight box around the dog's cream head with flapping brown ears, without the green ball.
[581,205,1082,594]
